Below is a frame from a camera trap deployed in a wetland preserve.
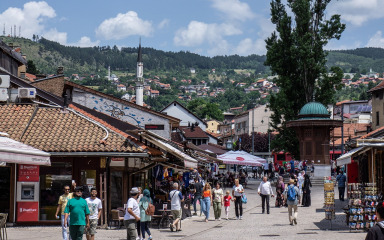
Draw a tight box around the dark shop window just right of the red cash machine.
[39,162,72,221]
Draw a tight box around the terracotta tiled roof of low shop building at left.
[0,104,143,152]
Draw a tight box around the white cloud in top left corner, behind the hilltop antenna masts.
[0,1,56,38]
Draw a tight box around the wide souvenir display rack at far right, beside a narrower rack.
[347,183,379,230]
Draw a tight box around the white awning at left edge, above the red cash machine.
[0,133,51,166]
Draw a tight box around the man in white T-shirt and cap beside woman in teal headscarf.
[124,187,140,240]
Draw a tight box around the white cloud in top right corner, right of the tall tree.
[328,0,384,26]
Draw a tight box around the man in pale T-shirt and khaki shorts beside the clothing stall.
[169,183,184,232]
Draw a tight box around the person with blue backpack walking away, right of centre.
[284,179,300,225]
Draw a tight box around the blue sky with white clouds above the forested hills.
[0,0,384,57]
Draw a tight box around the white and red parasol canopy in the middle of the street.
[217,151,266,166]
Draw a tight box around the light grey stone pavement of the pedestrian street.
[8,181,366,240]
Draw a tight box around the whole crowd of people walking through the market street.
[56,163,384,240]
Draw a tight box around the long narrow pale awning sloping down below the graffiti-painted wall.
[142,134,198,168]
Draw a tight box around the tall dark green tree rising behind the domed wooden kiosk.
[265,0,345,156]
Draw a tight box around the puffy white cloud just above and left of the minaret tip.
[96,11,153,40]
